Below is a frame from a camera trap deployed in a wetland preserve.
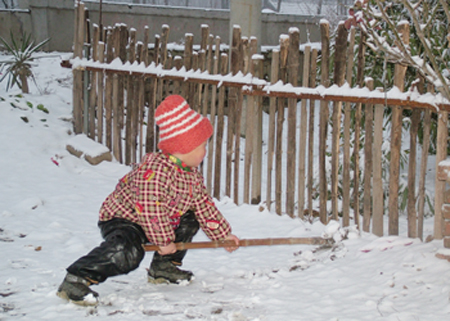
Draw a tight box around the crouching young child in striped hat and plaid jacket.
[57,95,239,305]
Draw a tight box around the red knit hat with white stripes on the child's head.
[155,95,213,154]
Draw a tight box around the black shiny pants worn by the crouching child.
[67,211,199,283]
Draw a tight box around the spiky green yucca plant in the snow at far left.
[0,32,50,94]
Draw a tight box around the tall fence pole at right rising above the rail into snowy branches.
[389,22,409,235]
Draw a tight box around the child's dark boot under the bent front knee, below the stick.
[148,253,194,284]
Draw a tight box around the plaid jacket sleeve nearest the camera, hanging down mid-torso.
[135,161,175,246]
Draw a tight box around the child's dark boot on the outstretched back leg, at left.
[56,273,98,306]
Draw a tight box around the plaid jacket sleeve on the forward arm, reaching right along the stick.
[194,172,231,241]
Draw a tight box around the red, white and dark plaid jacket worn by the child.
[100,153,231,246]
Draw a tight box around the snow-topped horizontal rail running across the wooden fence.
[72,59,450,112]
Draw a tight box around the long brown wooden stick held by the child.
[143,237,332,252]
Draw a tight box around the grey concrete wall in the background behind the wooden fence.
[0,0,321,52]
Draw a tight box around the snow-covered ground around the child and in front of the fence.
[0,55,450,321]
